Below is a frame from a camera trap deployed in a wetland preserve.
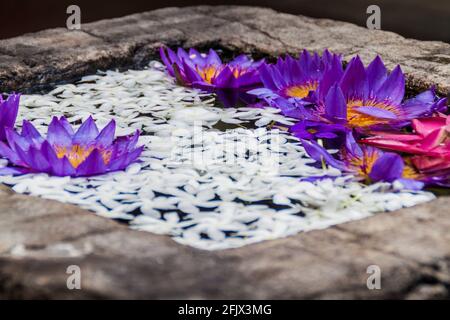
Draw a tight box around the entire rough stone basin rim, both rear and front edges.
[0,7,450,299]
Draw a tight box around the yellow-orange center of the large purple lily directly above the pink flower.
[347,100,400,128]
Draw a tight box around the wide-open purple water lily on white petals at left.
[0,117,143,177]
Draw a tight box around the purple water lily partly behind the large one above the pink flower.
[249,50,342,106]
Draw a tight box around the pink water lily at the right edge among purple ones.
[361,113,450,172]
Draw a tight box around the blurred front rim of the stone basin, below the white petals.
[0,186,450,299]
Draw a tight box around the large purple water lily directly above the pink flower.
[317,56,446,130]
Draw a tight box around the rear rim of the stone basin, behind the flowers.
[0,6,450,95]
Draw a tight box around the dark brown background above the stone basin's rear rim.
[0,0,450,43]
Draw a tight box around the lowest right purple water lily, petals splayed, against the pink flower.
[301,133,424,190]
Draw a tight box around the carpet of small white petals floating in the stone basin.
[0,62,434,250]
